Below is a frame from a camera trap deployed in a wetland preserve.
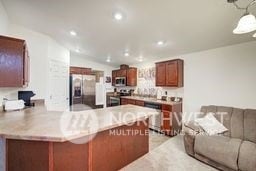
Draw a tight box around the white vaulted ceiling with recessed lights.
[2,0,255,66]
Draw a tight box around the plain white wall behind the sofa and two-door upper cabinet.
[132,41,256,121]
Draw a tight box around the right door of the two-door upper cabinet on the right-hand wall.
[166,61,178,86]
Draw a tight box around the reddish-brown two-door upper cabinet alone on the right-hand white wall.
[156,59,184,87]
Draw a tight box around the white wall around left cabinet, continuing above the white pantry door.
[0,24,70,109]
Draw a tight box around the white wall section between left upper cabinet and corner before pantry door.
[8,24,49,99]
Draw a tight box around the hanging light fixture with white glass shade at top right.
[228,0,256,34]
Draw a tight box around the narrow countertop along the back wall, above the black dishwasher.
[121,96,182,105]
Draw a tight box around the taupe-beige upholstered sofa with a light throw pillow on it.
[184,106,256,171]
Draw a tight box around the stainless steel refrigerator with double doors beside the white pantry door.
[70,74,97,110]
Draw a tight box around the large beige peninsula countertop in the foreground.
[0,105,157,142]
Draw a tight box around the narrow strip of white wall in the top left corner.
[0,0,9,35]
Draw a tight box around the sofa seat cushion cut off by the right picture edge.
[238,141,256,171]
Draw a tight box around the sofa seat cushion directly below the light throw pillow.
[195,135,241,170]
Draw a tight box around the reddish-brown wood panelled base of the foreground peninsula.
[6,120,149,171]
